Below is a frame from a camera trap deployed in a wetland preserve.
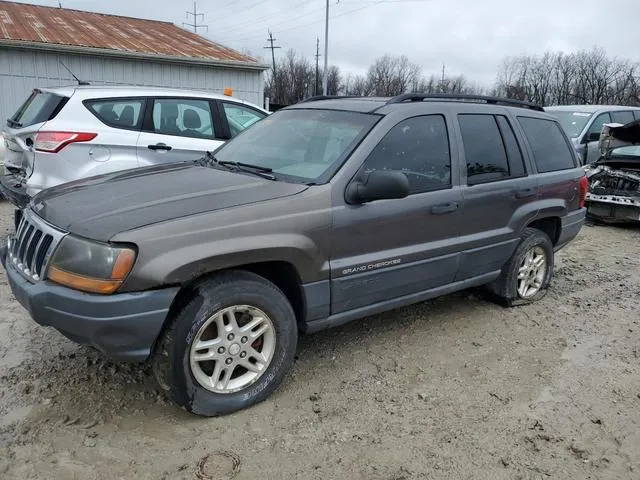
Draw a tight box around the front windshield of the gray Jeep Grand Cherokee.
[210,109,380,183]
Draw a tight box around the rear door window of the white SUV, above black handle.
[152,98,214,139]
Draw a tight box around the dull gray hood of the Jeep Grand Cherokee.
[31,163,308,242]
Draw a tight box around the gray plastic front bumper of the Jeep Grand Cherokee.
[0,246,179,362]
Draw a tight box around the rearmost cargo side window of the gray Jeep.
[518,117,576,173]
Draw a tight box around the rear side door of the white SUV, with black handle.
[137,97,224,166]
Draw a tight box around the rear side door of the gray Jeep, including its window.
[456,113,538,281]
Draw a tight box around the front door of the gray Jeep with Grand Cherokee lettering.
[330,115,462,314]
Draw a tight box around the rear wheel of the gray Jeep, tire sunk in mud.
[487,228,554,307]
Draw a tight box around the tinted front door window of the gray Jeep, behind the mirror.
[363,115,451,194]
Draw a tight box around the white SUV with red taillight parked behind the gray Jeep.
[0,86,269,206]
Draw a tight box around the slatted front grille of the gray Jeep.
[7,210,64,282]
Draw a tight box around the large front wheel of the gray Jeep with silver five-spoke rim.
[152,271,298,416]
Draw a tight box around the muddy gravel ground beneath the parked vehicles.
[0,202,640,480]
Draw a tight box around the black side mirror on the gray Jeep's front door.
[345,170,409,204]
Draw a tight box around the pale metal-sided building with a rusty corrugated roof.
[0,1,268,123]
